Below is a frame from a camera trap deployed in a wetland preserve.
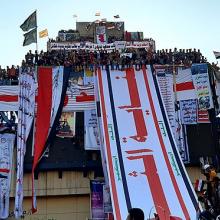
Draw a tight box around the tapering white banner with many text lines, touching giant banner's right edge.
[154,65,176,137]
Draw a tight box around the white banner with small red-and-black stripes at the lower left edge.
[0,133,15,219]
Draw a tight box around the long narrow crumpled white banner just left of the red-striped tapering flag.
[14,68,37,218]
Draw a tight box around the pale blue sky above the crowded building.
[0,0,220,67]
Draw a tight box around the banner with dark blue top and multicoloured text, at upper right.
[191,63,213,110]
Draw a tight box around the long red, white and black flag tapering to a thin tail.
[32,66,70,213]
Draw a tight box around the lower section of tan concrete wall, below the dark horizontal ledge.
[8,195,90,220]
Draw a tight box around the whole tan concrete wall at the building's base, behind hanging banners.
[8,167,203,220]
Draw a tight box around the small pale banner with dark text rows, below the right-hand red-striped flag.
[180,99,198,125]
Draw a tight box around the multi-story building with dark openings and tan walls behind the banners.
[6,21,220,220]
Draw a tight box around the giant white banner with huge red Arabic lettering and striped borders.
[97,66,198,220]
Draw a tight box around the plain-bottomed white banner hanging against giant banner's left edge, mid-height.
[84,109,100,150]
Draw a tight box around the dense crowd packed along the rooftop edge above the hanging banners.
[22,48,207,69]
